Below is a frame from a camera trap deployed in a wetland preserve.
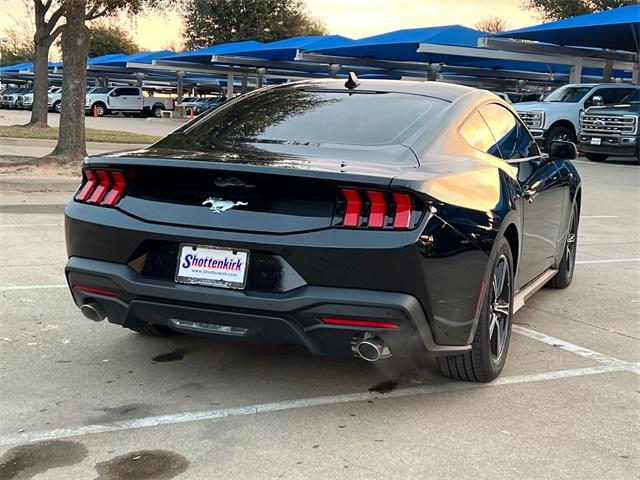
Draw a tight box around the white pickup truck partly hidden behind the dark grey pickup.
[514,83,638,151]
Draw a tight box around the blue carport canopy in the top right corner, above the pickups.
[496,5,640,52]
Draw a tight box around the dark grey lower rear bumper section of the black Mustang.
[66,257,470,356]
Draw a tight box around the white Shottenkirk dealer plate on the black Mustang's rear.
[175,244,249,289]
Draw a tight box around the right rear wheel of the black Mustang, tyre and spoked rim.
[438,238,513,382]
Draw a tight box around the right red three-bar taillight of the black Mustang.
[334,188,423,230]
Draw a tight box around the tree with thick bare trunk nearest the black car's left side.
[48,0,175,162]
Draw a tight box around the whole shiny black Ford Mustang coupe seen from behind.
[66,77,581,381]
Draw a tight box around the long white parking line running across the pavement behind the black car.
[0,364,640,446]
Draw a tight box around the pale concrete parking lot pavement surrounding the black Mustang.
[0,159,640,480]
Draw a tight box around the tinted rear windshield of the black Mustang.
[172,87,447,147]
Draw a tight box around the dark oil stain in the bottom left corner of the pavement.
[0,440,88,480]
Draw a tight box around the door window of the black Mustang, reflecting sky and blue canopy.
[480,103,540,160]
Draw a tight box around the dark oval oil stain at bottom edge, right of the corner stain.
[96,450,189,480]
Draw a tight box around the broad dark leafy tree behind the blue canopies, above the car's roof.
[184,0,327,49]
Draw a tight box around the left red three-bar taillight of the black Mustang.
[75,168,127,207]
